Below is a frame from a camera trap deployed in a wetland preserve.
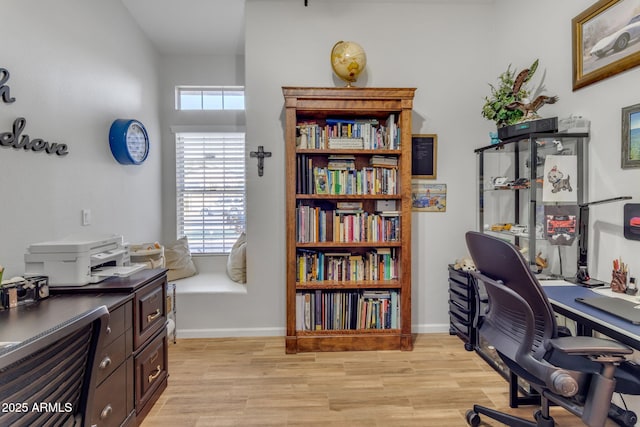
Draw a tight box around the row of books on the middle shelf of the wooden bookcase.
[296,204,400,243]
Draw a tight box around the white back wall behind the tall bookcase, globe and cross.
[245,0,495,332]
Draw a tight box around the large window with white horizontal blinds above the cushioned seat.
[176,132,246,254]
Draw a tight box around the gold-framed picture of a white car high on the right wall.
[571,0,640,91]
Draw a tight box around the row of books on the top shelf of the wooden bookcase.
[296,114,401,150]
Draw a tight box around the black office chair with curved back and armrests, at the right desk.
[466,232,640,427]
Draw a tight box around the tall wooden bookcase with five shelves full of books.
[283,87,415,353]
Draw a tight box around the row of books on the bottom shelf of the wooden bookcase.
[296,290,400,331]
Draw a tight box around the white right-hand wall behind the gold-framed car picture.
[496,0,640,280]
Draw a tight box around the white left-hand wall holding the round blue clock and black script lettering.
[0,0,162,278]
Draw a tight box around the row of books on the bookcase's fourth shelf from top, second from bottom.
[296,248,399,283]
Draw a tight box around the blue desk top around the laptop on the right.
[540,281,640,350]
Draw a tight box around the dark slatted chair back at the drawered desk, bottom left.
[0,306,109,426]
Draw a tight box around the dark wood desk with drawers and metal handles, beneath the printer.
[0,269,168,427]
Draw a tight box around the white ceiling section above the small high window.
[122,0,245,55]
